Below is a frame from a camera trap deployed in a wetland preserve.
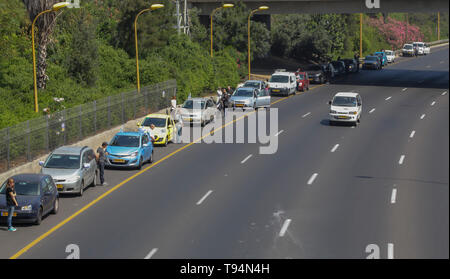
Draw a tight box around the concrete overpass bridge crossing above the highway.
[187,0,449,15]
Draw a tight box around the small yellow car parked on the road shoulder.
[137,113,175,146]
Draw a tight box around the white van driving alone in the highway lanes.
[329,92,362,126]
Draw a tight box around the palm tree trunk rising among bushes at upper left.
[23,0,58,89]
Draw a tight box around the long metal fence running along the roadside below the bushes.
[0,80,177,173]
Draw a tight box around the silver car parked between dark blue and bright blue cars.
[39,146,97,196]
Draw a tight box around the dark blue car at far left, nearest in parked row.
[0,173,59,225]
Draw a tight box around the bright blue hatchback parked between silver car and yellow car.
[105,131,153,169]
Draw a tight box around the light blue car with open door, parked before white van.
[230,87,270,110]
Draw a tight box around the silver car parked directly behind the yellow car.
[180,98,217,126]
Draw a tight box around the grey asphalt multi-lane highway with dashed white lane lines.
[0,46,449,259]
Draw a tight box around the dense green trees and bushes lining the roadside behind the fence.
[0,0,448,129]
